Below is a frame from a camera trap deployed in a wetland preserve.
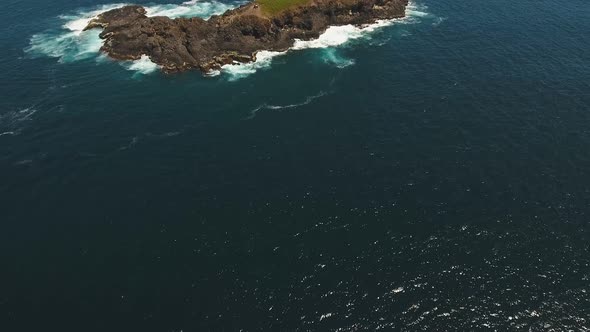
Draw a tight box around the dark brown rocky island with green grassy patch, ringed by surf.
[85,0,408,73]
